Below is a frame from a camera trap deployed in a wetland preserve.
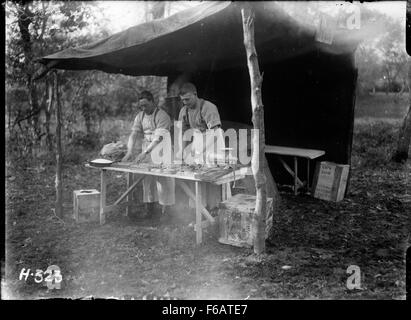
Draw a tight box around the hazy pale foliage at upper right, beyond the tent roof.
[277,1,409,95]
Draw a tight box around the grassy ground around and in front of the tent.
[2,93,411,299]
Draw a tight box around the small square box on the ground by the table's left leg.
[73,189,100,222]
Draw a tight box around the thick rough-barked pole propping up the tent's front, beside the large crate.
[241,4,267,254]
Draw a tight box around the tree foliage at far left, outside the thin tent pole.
[5,1,107,157]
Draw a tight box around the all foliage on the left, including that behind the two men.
[5,1,165,159]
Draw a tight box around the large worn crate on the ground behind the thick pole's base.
[218,193,273,247]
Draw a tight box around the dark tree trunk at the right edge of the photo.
[392,63,411,162]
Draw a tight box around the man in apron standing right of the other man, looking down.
[178,83,224,209]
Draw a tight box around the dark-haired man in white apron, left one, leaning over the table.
[122,91,175,219]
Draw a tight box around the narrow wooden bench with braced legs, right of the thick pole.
[264,145,325,195]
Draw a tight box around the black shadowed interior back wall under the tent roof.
[180,52,356,182]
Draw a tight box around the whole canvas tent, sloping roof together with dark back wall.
[40,2,359,185]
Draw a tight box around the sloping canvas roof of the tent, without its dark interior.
[39,2,358,76]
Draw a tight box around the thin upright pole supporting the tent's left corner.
[54,71,63,217]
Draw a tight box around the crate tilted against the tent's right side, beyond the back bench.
[313,161,350,202]
